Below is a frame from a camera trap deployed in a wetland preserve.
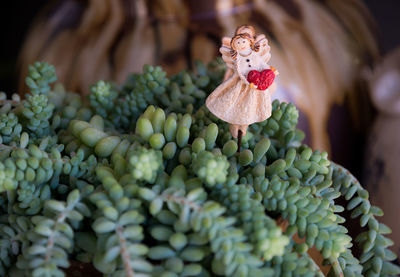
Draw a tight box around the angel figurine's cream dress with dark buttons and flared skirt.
[206,39,271,125]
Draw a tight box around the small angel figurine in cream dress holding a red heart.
[206,25,279,151]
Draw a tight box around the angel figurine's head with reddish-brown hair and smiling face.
[231,25,259,59]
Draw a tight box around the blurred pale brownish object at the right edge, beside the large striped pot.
[363,45,400,255]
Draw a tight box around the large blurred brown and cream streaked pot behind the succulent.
[15,0,379,161]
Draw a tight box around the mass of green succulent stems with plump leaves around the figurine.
[0,60,400,277]
